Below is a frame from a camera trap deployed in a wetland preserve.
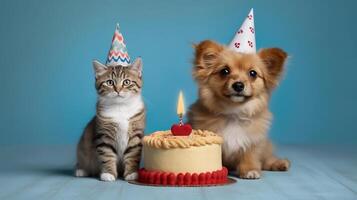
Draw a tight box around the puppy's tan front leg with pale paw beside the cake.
[237,147,261,179]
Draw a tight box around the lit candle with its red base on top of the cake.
[171,91,192,136]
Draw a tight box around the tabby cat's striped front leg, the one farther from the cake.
[96,142,118,181]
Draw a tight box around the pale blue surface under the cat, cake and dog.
[0,145,357,200]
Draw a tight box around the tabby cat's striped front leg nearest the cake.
[124,135,142,181]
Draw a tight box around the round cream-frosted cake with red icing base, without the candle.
[139,130,228,186]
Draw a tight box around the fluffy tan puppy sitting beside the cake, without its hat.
[188,40,290,179]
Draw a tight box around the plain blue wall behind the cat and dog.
[0,0,357,144]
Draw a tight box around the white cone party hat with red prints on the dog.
[229,8,256,53]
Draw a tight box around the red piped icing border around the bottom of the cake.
[139,167,228,186]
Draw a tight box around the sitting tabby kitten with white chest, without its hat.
[75,58,145,181]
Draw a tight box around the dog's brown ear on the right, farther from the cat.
[258,48,288,89]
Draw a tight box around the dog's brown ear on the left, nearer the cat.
[193,40,223,80]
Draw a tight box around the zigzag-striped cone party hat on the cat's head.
[106,24,130,66]
